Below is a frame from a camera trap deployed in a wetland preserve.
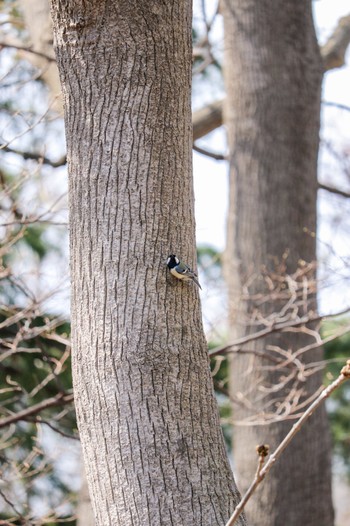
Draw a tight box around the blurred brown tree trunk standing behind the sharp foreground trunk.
[223,0,333,526]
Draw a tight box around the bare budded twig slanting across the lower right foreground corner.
[226,360,350,526]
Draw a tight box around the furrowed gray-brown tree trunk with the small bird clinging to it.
[52,0,245,526]
